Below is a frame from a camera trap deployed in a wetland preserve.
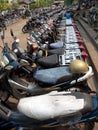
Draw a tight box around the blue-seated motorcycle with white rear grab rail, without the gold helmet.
[0,44,93,101]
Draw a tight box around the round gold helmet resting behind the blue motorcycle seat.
[69,59,88,74]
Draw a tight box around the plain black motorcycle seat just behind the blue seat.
[37,54,59,68]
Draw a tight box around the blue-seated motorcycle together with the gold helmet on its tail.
[0,30,93,99]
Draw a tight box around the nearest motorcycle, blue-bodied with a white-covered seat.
[0,91,98,130]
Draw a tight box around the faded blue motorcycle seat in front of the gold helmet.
[34,66,73,85]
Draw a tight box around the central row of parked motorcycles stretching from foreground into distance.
[0,6,98,130]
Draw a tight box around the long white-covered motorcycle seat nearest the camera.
[17,91,92,121]
